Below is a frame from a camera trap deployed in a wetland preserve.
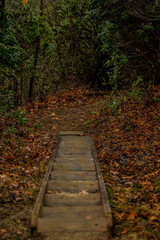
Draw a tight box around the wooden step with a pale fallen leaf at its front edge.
[47,181,99,193]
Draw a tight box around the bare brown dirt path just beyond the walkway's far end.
[37,92,101,131]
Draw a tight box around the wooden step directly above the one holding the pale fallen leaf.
[50,171,97,181]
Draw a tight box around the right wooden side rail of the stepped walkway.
[88,135,112,227]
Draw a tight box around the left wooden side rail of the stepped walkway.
[31,136,60,229]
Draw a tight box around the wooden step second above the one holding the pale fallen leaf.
[53,162,95,171]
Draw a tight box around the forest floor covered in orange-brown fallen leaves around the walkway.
[0,89,160,240]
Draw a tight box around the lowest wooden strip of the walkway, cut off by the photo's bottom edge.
[46,232,110,240]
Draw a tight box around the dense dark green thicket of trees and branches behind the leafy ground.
[0,0,160,110]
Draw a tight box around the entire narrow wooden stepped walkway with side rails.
[31,132,112,240]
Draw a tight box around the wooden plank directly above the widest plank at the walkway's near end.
[40,206,104,219]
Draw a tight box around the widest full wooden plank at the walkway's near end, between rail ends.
[38,217,107,233]
